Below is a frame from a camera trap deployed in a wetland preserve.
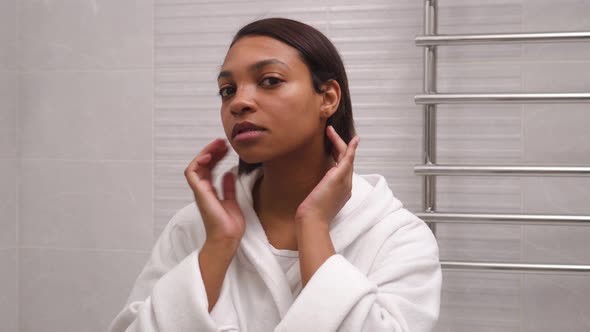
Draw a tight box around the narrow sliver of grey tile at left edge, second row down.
[0,70,19,158]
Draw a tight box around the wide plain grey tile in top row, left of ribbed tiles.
[20,0,153,70]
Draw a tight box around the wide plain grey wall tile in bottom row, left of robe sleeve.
[20,249,149,332]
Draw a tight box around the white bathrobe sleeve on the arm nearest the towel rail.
[275,211,442,332]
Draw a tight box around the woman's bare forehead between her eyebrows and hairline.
[221,36,305,71]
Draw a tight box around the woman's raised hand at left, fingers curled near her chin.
[184,139,246,249]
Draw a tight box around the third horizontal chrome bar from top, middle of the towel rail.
[414,165,590,176]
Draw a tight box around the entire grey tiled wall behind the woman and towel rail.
[0,0,590,332]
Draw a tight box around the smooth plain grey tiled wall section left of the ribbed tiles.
[14,0,154,331]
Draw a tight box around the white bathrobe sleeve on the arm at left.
[109,204,238,332]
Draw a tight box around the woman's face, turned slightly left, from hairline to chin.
[218,36,326,163]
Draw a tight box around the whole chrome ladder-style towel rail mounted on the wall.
[414,0,590,273]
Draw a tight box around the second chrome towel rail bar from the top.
[414,92,590,105]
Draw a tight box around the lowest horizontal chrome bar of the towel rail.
[441,261,590,273]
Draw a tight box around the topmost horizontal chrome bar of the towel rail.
[415,31,590,46]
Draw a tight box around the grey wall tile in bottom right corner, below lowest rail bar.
[522,274,590,332]
